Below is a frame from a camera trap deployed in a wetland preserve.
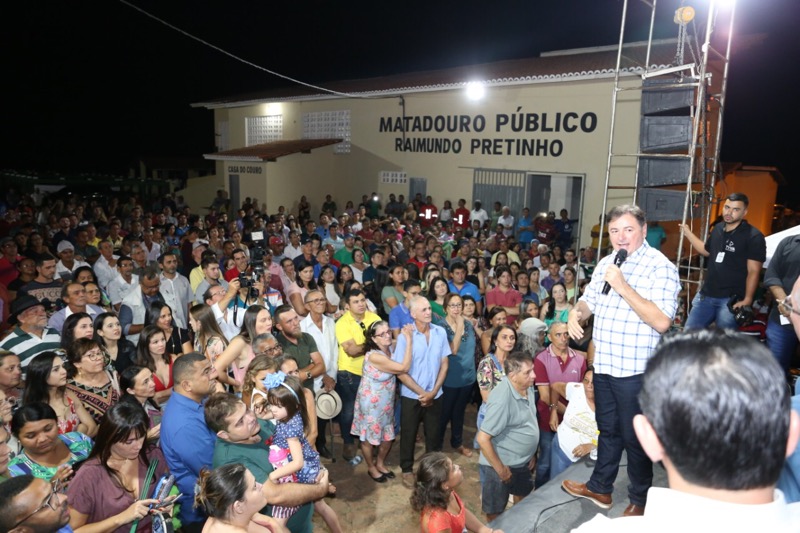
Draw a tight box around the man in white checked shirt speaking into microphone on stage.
[561,205,680,516]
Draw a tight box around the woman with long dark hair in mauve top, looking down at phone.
[68,402,169,533]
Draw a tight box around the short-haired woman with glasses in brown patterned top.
[66,339,119,424]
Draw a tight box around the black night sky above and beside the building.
[0,0,800,202]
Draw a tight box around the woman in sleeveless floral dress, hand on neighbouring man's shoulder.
[350,320,413,483]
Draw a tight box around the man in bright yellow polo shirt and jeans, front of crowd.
[336,289,380,461]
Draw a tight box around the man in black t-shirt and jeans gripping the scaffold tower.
[680,192,767,329]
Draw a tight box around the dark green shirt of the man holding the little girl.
[211,420,314,533]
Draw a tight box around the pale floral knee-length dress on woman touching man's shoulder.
[350,351,395,446]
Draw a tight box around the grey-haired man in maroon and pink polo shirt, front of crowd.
[533,322,586,487]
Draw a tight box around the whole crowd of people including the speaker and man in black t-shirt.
[0,188,800,533]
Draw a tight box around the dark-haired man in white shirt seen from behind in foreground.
[576,330,800,533]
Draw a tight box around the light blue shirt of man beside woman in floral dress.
[392,324,450,400]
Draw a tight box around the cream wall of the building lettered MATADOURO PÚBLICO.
[215,76,640,243]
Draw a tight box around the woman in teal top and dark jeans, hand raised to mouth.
[437,292,476,457]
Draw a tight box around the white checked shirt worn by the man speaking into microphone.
[581,241,680,377]
